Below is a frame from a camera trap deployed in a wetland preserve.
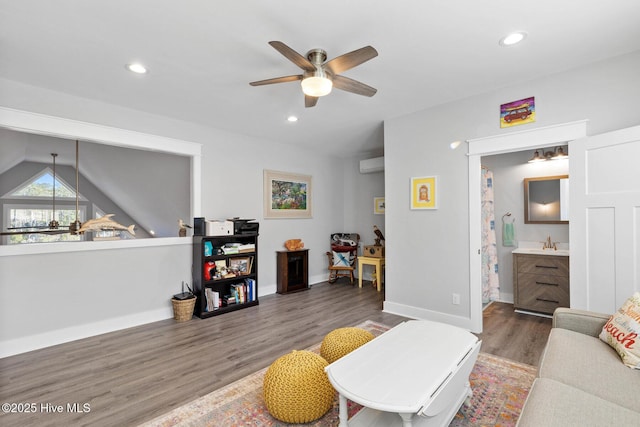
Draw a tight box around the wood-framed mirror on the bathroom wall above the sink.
[524,175,569,224]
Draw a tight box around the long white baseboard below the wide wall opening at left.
[0,307,173,358]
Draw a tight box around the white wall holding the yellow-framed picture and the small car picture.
[385,52,640,328]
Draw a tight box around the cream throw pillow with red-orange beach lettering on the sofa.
[600,292,640,369]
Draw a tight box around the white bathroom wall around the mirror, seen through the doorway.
[482,150,571,303]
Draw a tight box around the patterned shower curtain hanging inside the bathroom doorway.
[482,168,500,304]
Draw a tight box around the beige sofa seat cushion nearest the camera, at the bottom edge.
[517,378,640,427]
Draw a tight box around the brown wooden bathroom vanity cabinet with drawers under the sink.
[513,252,569,315]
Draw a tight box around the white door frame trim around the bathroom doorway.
[467,120,588,333]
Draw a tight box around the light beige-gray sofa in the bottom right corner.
[517,308,640,427]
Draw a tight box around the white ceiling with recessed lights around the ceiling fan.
[0,0,640,155]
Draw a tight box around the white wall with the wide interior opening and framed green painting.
[0,79,364,357]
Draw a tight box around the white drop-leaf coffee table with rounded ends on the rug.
[325,320,481,427]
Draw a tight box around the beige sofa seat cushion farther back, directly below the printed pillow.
[538,328,640,412]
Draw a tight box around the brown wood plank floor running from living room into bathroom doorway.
[0,279,551,426]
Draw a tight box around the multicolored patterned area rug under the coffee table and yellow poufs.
[142,320,536,427]
